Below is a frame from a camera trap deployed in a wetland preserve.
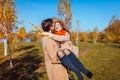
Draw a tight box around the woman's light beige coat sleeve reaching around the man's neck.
[51,32,70,41]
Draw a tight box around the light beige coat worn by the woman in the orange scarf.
[50,32,79,57]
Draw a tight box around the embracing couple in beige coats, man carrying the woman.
[41,18,93,80]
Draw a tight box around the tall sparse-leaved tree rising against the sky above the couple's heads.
[58,0,72,29]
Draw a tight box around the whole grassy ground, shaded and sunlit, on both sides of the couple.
[0,42,120,80]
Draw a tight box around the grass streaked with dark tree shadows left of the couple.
[0,43,47,80]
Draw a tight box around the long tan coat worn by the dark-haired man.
[42,36,69,80]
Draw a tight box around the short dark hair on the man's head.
[41,18,53,32]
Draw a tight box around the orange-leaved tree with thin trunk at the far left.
[0,0,17,67]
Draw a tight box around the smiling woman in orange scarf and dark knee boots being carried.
[42,19,92,80]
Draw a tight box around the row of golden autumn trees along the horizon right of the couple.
[71,19,120,44]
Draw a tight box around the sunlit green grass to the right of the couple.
[79,43,120,80]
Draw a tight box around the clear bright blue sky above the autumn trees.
[15,0,120,32]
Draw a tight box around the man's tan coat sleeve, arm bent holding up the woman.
[46,40,61,64]
